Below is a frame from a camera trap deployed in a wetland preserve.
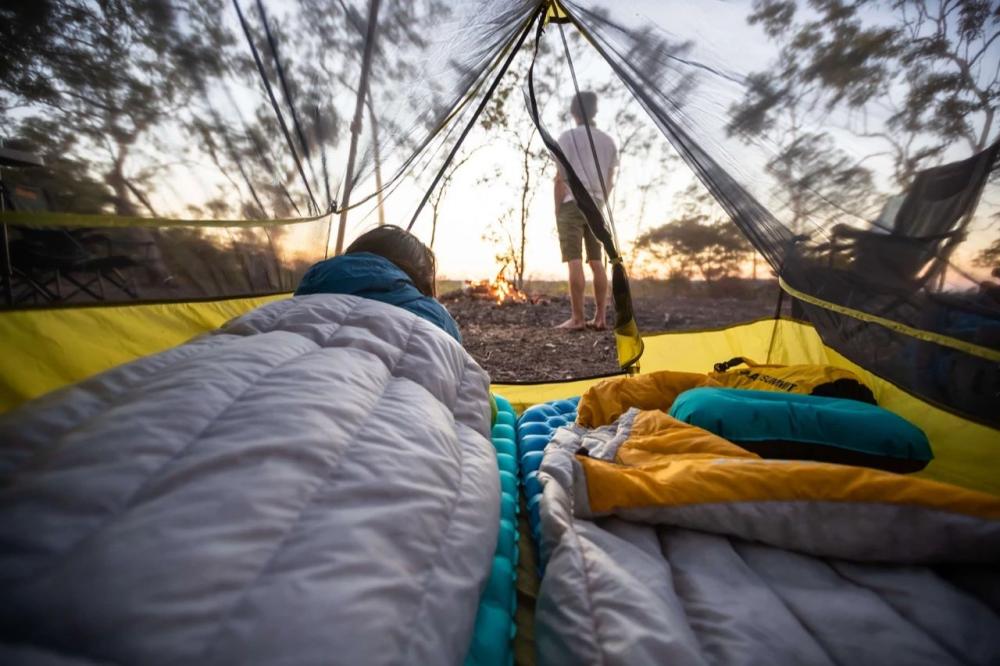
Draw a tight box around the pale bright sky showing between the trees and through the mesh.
[11,0,1000,286]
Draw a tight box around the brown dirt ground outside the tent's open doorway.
[441,282,792,383]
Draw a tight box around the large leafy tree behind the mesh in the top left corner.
[0,0,240,215]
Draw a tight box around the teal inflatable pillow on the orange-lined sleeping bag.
[670,388,934,472]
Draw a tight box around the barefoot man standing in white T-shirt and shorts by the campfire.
[555,92,618,331]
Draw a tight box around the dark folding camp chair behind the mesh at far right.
[820,142,1000,295]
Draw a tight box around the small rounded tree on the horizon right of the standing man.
[636,184,753,285]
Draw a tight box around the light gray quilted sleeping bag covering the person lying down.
[0,295,500,664]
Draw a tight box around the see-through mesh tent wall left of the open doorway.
[0,0,536,300]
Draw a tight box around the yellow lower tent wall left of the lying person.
[0,294,288,413]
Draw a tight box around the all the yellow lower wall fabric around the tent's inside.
[0,295,1000,495]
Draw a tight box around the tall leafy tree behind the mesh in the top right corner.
[730,0,1000,188]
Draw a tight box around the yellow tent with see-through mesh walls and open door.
[0,0,1000,492]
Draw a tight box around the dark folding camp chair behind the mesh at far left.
[3,185,138,305]
